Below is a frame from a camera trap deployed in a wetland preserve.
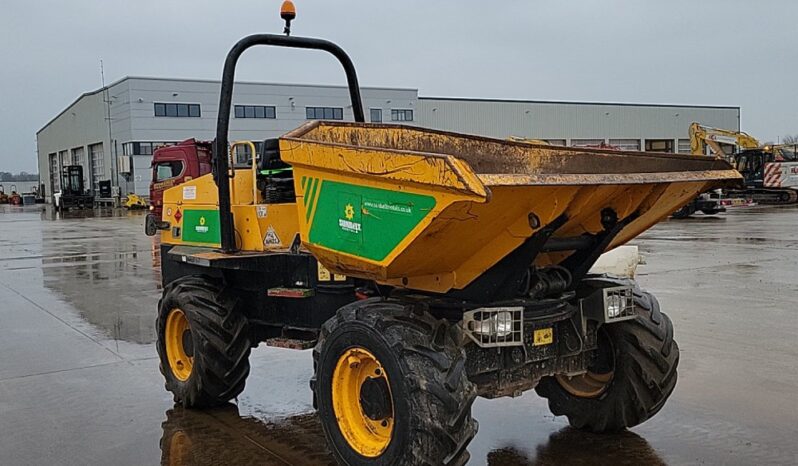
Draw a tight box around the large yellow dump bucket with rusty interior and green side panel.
[280,122,740,292]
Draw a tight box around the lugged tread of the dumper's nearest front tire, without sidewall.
[311,299,478,466]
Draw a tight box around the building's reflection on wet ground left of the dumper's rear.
[40,209,161,344]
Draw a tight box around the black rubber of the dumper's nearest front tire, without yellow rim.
[311,298,478,466]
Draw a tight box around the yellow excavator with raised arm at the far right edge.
[690,123,798,205]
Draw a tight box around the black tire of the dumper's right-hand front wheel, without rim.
[536,290,679,433]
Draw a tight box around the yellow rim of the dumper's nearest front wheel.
[332,348,394,458]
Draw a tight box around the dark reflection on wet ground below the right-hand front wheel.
[487,427,666,466]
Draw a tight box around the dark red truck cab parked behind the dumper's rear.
[146,139,212,235]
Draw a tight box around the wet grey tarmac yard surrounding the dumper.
[0,206,798,465]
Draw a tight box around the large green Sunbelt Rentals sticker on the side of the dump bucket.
[306,180,435,261]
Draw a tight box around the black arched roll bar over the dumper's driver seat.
[213,34,366,253]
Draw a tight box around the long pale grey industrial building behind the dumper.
[36,77,740,198]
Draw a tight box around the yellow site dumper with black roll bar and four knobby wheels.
[150,18,739,465]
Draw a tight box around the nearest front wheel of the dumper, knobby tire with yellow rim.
[311,299,477,466]
